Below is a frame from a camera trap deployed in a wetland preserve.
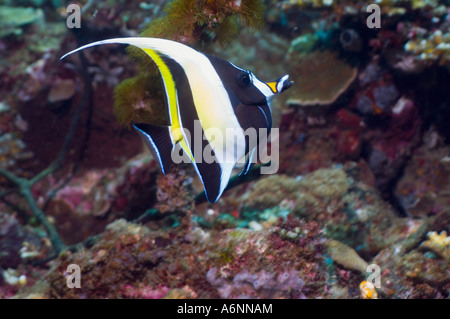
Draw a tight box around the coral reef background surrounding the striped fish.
[0,0,450,299]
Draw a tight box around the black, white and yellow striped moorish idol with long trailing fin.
[61,37,292,203]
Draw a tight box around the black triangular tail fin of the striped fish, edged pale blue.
[133,123,175,174]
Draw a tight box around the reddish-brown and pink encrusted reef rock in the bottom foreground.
[45,217,325,298]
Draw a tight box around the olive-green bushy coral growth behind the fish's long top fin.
[114,0,265,125]
